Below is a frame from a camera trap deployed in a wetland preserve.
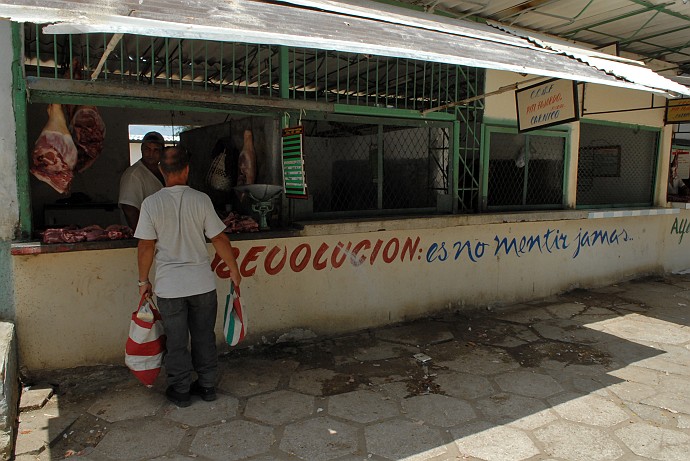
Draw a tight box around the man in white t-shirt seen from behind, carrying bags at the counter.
[134,147,242,407]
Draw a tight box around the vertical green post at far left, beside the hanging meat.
[11,22,33,238]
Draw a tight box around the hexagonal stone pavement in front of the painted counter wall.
[16,275,690,461]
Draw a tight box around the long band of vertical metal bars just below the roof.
[25,24,483,110]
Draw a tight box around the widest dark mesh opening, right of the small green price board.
[304,120,452,215]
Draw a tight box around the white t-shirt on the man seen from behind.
[134,186,226,298]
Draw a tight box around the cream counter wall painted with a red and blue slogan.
[13,210,690,370]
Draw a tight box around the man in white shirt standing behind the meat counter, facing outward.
[118,131,165,229]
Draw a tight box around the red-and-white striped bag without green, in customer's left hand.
[125,295,165,387]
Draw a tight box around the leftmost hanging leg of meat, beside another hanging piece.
[30,104,77,194]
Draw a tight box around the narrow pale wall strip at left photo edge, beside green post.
[0,20,19,240]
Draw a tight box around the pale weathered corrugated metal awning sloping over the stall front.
[0,0,690,94]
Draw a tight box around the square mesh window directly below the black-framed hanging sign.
[487,130,565,209]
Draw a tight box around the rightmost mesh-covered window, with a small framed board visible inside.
[577,122,659,206]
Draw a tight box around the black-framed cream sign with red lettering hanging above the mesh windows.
[515,79,580,132]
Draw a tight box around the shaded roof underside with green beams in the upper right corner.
[390,0,690,74]
